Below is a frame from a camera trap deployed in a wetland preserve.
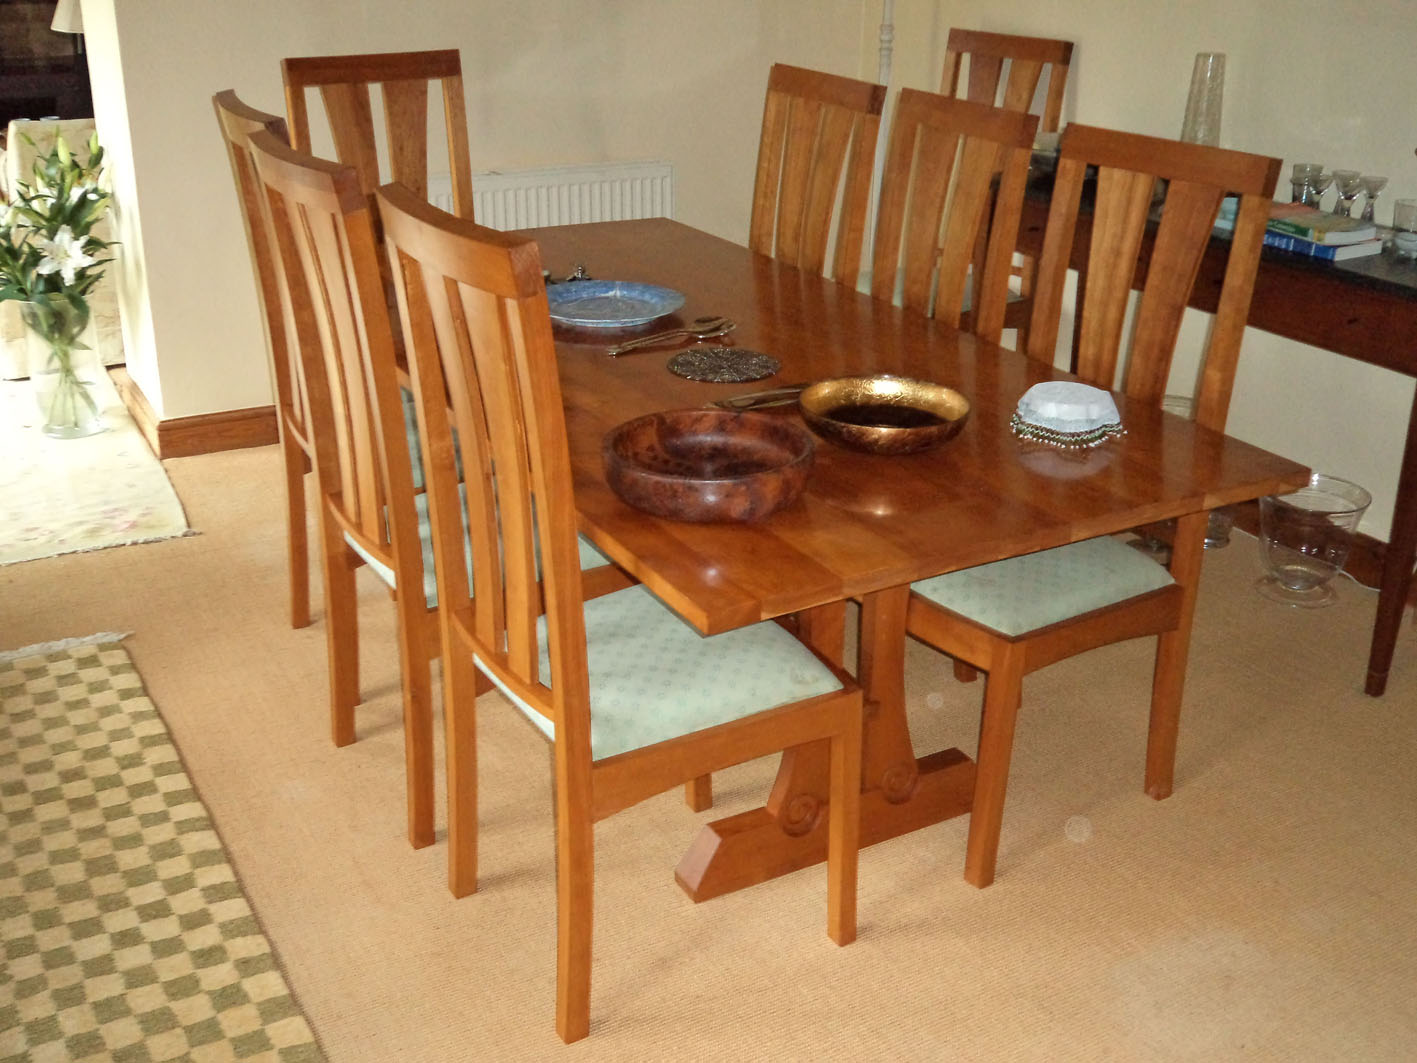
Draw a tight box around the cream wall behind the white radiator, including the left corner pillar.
[84,0,862,420]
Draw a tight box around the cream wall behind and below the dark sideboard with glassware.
[862,0,1417,539]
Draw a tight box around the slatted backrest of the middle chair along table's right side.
[871,88,1039,343]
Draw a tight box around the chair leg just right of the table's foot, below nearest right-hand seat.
[965,646,1023,889]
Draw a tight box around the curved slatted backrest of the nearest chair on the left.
[378,184,591,748]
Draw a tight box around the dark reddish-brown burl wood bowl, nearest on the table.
[601,410,815,523]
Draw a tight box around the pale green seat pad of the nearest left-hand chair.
[489,585,842,760]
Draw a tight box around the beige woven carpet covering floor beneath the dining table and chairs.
[0,448,1417,1062]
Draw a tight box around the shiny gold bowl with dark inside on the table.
[798,373,969,454]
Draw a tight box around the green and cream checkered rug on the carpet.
[0,642,323,1063]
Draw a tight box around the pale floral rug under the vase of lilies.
[0,373,188,566]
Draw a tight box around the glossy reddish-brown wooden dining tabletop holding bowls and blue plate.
[533,218,1308,634]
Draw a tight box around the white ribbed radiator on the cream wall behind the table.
[428,162,674,230]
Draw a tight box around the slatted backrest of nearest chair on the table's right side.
[1029,123,1281,429]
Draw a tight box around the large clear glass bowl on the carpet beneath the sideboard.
[1255,472,1373,609]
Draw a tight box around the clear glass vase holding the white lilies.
[20,295,103,439]
